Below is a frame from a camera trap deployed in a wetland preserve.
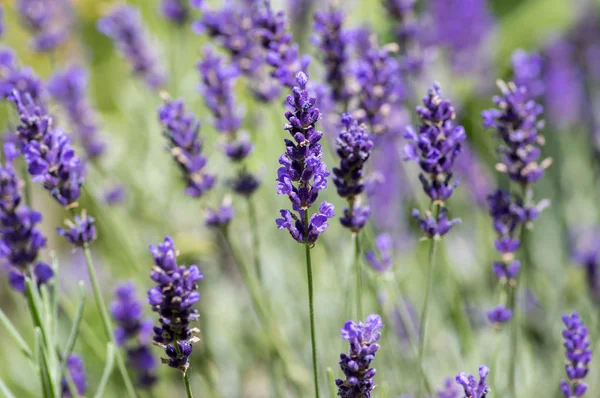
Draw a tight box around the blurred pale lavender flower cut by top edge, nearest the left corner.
[17,0,70,52]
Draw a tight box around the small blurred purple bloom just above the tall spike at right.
[512,49,544,100]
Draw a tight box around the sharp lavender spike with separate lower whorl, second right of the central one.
[404,85,467,238]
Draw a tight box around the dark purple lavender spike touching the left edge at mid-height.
[0,143,54,292]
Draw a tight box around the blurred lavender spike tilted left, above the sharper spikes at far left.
[48,66,105,158]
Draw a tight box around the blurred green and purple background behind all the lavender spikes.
[0,0,600,397]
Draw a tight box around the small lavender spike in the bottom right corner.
[560,312,592,398]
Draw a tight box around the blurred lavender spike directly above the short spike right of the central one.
[353,44,405,135]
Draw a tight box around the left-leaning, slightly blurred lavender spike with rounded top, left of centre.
[158,99,215,198]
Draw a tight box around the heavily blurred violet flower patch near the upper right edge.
[544,39,586,129]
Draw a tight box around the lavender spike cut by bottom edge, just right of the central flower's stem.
[335,314,383,398]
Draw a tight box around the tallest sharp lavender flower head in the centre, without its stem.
[276,72,335,244]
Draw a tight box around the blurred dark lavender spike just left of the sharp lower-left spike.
[110,282,156,388]
